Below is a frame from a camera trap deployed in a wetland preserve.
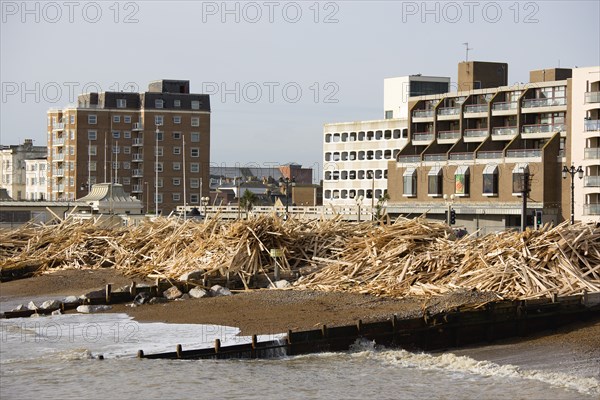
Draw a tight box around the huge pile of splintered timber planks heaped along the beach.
[0,216,600,299]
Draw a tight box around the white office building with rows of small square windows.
[323,75,450,207]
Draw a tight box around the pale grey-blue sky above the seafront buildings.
[0,0,600,176]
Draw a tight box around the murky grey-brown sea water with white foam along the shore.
[0,314,600,400]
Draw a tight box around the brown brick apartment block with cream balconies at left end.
[47,80,211,215]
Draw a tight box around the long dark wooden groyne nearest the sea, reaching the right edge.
[137,293,600,359]
